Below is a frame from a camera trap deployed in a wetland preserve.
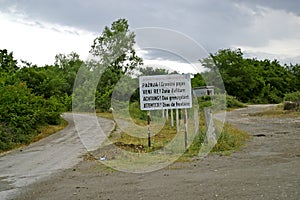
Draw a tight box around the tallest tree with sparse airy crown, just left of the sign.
[90,19,143,111]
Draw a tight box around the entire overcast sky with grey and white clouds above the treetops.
[0,0,300,72]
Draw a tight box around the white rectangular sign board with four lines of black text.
[139,74,192,110]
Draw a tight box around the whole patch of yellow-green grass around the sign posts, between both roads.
[95,97,249,166]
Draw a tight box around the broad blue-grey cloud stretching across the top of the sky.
[0,0,300,63]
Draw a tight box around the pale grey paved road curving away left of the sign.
[0,113,114,199]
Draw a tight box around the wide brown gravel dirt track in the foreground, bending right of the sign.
[4,105,300,200]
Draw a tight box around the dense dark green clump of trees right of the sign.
[195,49,300,103]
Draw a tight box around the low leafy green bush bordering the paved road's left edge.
[0,82,63,151]
